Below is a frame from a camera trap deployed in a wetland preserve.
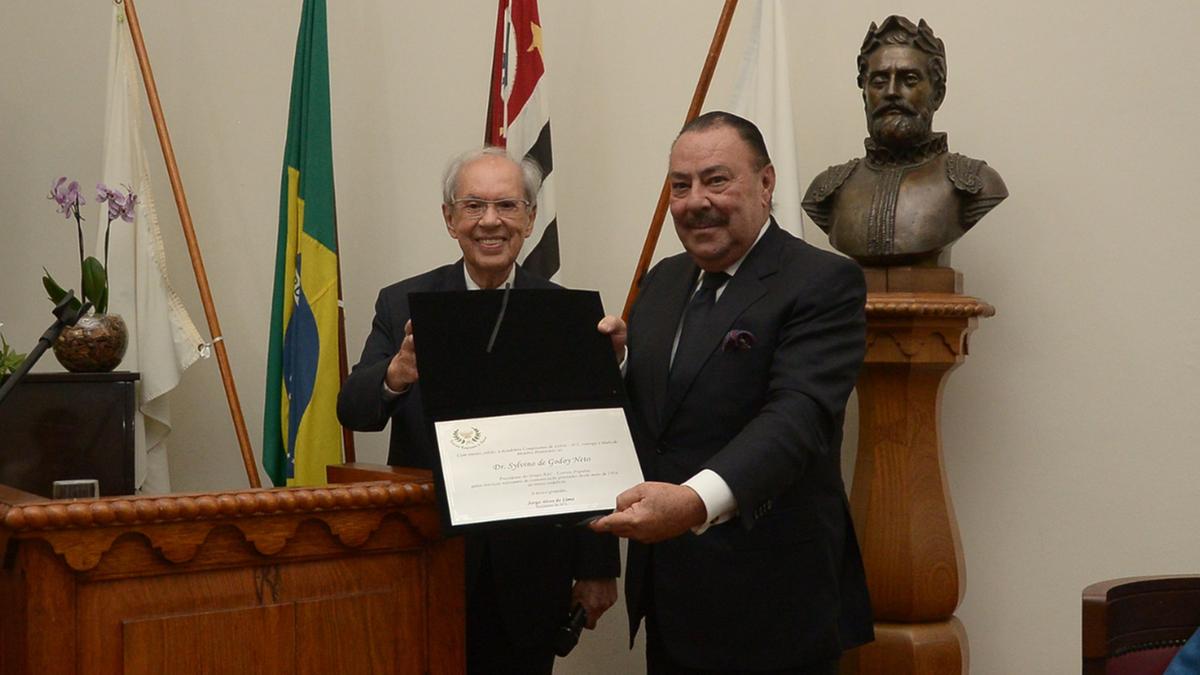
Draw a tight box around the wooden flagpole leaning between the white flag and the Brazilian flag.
[116,0,263,488]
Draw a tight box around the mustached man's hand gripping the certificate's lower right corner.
[590,483,708,544]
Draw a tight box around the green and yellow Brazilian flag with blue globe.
[263,0,342,486]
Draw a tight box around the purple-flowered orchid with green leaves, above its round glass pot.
[42,177,138,313]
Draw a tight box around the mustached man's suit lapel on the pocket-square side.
[656,220,782,429]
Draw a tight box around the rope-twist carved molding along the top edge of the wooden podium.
[0,483,436,532]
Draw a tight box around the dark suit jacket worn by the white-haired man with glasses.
[337,259,620,646]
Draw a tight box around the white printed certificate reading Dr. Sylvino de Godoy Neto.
[433,408,642,526]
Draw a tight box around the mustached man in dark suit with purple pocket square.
[593,112,872,675]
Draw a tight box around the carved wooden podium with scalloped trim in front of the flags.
[0,472,464,675]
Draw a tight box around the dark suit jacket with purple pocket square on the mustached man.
[625,222,872,669]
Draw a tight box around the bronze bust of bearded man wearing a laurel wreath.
[803,16,1008,265]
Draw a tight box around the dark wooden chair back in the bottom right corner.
[1082,574,1200,675]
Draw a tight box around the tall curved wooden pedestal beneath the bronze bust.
[842,268,995,675]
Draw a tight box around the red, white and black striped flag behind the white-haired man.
[484,0,559,279]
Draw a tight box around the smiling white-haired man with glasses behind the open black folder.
[337,148,619,675]
